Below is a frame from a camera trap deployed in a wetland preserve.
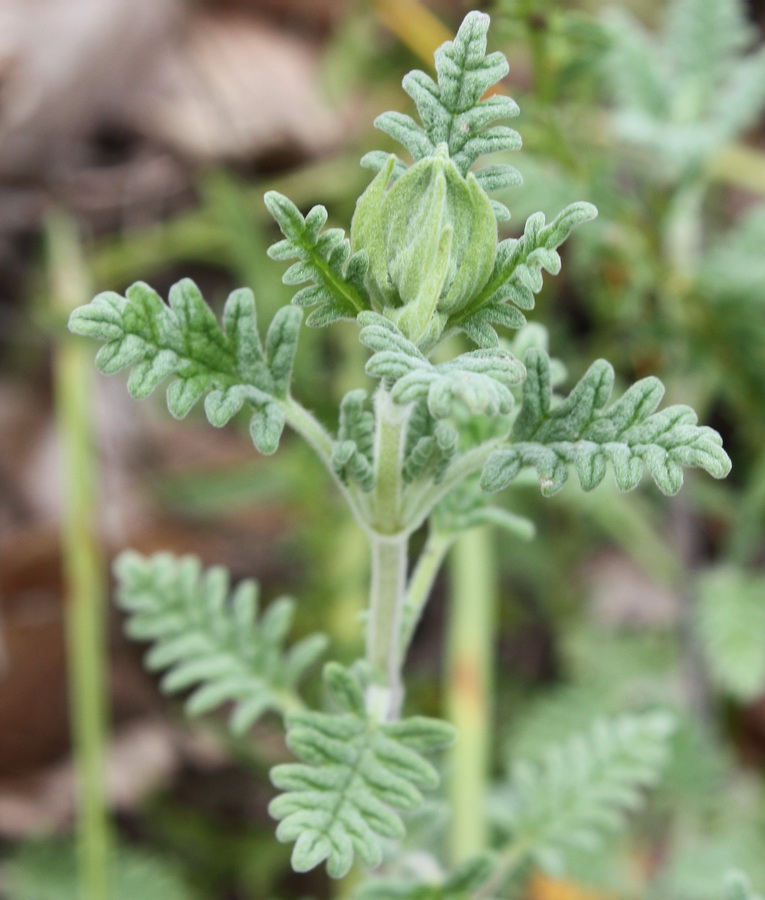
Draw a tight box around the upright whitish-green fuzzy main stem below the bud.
[367,385,409,720]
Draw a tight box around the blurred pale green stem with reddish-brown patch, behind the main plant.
[447,526,496,863]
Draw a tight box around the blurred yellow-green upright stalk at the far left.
[48,216,111,900]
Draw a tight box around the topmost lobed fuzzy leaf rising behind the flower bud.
[361,12,521,218]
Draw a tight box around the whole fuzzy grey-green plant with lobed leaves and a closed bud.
[70,12,730,898]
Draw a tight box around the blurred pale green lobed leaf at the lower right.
[498,712,674,873]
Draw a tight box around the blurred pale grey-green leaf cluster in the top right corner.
[607,0,765,183]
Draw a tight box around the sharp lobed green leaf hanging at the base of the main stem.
[269,663,454,878]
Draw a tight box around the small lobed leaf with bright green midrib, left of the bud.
[265,191,370,327]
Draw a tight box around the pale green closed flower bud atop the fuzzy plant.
[351,144,497,343]
